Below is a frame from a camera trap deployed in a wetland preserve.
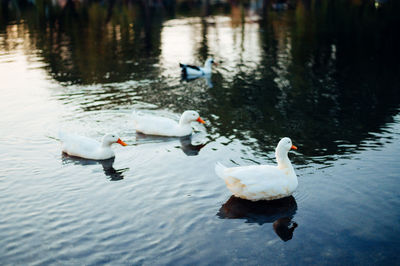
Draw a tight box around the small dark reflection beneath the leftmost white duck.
[61,153,129,181]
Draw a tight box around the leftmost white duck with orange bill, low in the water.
[59,132,127,160]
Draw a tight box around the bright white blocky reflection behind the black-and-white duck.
[160,16,261,78]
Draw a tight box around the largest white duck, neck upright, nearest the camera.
[215,138,298,201]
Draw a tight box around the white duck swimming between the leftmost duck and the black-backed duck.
[132,110,205,137]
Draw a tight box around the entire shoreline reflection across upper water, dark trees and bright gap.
[0,0,400,166]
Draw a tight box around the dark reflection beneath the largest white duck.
[217,196,297,241]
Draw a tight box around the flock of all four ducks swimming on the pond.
[59,59,298,201]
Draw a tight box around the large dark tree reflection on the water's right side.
[205,1,400,162]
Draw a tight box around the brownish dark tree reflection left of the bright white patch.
[1,1,161,84]
